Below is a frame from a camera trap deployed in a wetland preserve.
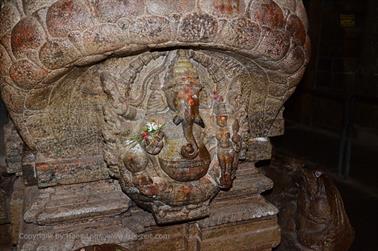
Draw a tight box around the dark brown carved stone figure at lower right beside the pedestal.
[265,155,354,250]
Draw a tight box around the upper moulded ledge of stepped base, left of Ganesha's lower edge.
[24,181,130,225]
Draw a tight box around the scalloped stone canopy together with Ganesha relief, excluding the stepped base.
[0,0,310,226]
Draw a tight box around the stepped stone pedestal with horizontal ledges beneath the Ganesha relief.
[19,163,280,251]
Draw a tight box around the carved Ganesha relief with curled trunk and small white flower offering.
[101,50,242,223]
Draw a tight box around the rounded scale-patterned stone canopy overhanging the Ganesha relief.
[0,0,310,151]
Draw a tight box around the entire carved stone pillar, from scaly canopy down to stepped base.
[0,0,310,250]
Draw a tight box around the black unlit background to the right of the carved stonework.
[272,0,378,251]
